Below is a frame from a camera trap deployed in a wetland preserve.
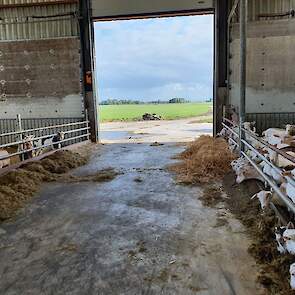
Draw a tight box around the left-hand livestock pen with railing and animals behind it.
[0,112,90,168]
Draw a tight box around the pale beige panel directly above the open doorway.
[91,0,213,19]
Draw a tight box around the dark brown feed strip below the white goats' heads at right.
[224,174,295,295]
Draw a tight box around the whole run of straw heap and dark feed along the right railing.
[174,137,295,295]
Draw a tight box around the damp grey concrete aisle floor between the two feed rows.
[0,122,258,295]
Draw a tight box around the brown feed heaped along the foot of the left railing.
[0,150,118,220]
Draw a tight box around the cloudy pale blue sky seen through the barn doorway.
[95,15,213,101]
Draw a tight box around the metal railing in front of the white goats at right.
[222,118,295,214]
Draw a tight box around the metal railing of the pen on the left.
[0,112,90,161]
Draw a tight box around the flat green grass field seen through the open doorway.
[100,103,212,122]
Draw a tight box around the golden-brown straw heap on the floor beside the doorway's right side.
[169,135,235,184]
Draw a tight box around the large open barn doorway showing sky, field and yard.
[94,14,214,143]
